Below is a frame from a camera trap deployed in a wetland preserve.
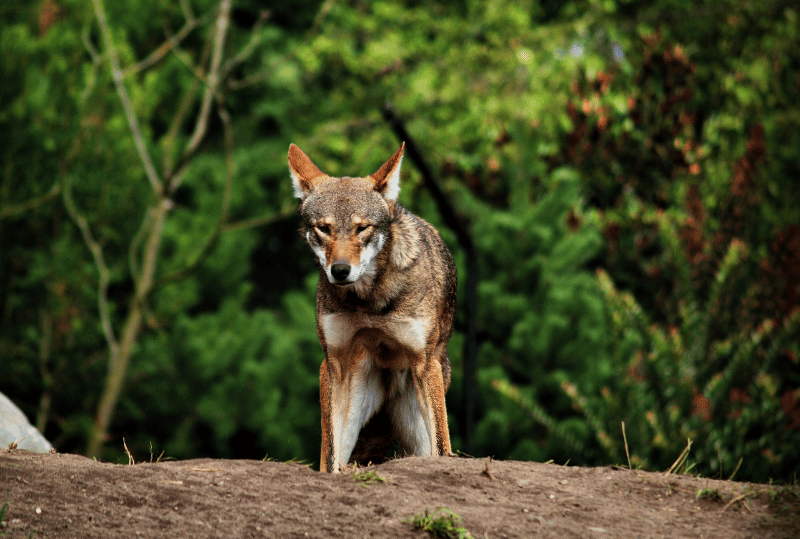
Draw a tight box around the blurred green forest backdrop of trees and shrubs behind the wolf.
[0,0,800,481]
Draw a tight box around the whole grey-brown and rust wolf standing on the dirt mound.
[289,143,456,472]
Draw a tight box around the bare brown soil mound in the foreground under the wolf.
[0,450,800,539]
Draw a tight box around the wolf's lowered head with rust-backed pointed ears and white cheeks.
[289,143,405,289]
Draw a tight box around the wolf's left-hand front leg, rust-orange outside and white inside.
[320,355,385,473]
